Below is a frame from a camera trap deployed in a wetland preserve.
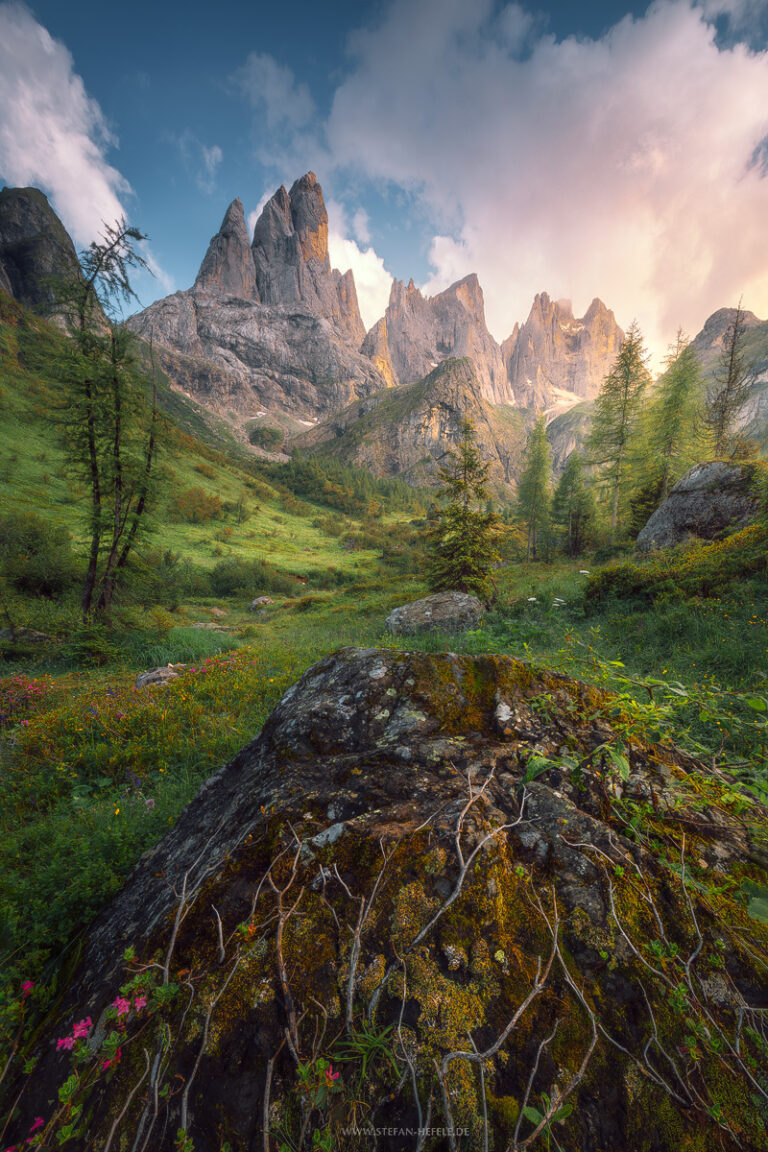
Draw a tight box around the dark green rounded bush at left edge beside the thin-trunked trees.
[0,513,77,599]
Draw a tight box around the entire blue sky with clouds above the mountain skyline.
[0,0,768,363]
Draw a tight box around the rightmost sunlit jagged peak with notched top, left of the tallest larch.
[502,293,624,415]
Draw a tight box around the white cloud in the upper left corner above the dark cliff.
[0,2,130,245]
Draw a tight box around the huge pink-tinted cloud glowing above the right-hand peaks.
[327,0,768,353]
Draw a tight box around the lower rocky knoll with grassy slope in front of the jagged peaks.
[295,359,525,488]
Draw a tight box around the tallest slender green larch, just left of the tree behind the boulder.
[587,321,651,544]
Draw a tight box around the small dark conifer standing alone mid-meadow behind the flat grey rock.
[427,420,499,599]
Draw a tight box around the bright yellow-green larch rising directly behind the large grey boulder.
[647,328,704,502]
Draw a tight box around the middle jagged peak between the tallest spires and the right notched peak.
[385,274,514,404]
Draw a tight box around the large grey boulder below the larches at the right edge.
[636,460,760,552]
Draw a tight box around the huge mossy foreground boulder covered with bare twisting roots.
[5,649,768,1152]
